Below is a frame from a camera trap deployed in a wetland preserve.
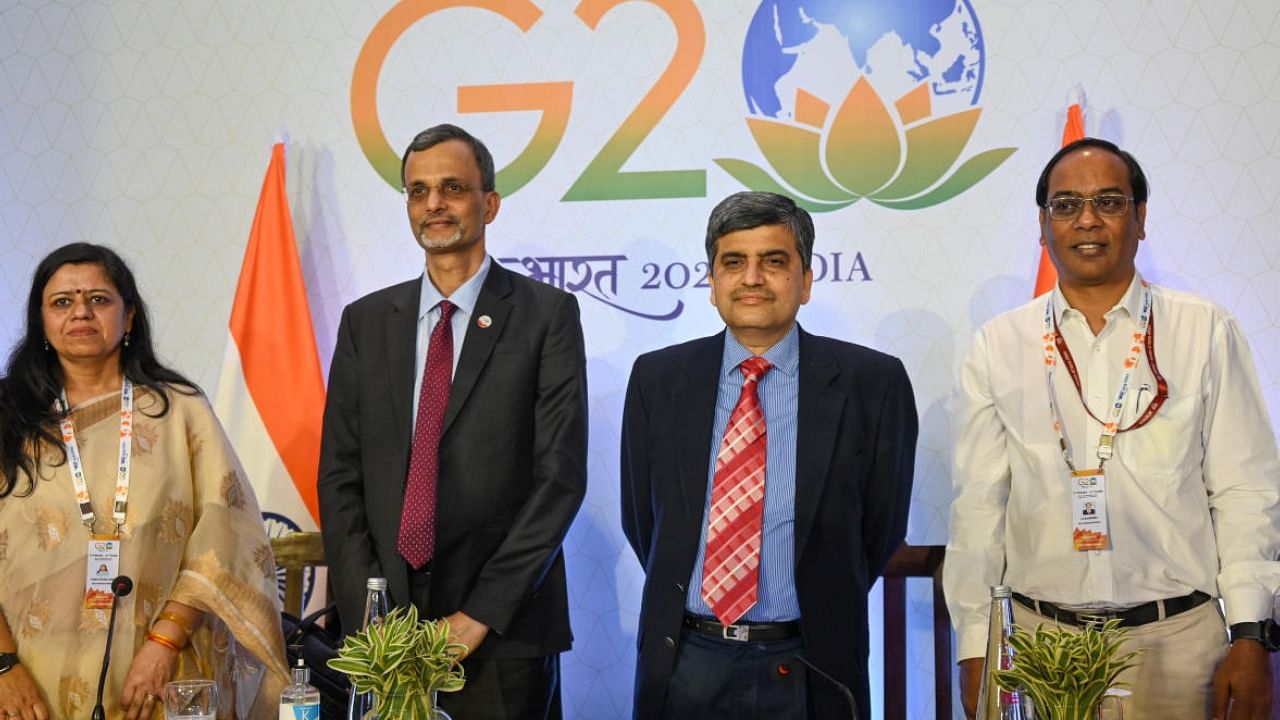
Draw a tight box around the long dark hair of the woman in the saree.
[0,242,200,498]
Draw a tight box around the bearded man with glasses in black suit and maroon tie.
[319,124,588,720]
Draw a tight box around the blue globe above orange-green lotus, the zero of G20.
[716,0,1015,211]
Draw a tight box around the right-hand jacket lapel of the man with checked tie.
[795,329,845,561]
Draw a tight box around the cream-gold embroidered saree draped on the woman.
[0,388,289,720]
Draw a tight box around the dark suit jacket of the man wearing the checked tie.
[621,331,916,719]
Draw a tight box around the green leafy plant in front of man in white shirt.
[995,620,1139,720]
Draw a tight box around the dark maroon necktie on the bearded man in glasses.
[396,300,457,569]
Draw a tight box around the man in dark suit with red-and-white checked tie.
[621,192,916,720]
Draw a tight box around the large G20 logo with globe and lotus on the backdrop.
[351,0,1015,211]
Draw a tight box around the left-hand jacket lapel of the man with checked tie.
[668,333,724,532]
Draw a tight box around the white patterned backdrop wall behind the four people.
[0,0,1280,719]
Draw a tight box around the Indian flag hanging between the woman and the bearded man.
[214,142,324,609]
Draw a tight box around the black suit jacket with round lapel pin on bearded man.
[317,261,588,657]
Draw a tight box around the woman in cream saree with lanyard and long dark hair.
[0,243,288,720]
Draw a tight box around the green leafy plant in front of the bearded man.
[329,605,466,720]
